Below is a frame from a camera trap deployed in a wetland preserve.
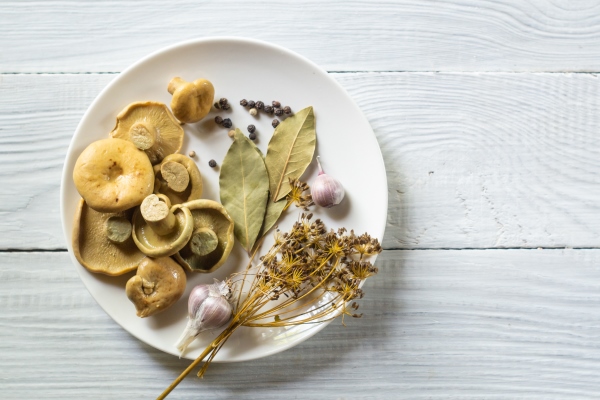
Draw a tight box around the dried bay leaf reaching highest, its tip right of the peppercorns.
[265,107,317,202]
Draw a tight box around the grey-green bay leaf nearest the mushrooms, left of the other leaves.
[219,129,269,251]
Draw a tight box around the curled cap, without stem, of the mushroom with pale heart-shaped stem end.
[131,204,194,257]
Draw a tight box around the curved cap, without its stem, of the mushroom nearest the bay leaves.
[175,199,234,272]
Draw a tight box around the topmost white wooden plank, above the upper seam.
[0,0,600,73]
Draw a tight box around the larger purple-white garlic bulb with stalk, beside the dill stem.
[175,279,232,354]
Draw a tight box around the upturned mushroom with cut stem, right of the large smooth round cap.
[154,154,203,204]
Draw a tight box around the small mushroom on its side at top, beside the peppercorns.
[169,78,215,123]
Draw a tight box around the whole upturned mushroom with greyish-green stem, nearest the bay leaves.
[175,199,234,272]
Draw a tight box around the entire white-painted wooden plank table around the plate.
[0,0,600,399]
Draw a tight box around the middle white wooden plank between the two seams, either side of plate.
[0,73,600,249]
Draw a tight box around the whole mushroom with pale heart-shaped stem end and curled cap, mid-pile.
[132,194,194,257]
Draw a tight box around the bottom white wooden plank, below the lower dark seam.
[0,250,600,399]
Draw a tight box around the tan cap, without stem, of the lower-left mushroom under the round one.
[73,199,146,276]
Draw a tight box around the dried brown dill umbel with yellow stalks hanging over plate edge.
[158,212,381,399]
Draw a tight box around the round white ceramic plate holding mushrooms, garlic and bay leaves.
[61,38,387,361]
